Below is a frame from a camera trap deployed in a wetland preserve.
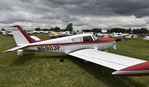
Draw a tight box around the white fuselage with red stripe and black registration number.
[26,34,115,53]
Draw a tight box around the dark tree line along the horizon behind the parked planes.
[1,23,149,34]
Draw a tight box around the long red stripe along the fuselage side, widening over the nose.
[29,38,115,47]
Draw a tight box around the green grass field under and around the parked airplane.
[0,34,149,87]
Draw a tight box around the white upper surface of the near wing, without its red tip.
[69,49,146,70]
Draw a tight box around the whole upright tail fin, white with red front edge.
[11,25,34,45]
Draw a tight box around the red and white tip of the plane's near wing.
[112,62,149,76]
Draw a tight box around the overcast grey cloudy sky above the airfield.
[0,0,149,29]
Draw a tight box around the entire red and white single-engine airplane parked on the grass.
[4,25,149,76]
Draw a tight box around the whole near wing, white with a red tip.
[68,49,149,76]
